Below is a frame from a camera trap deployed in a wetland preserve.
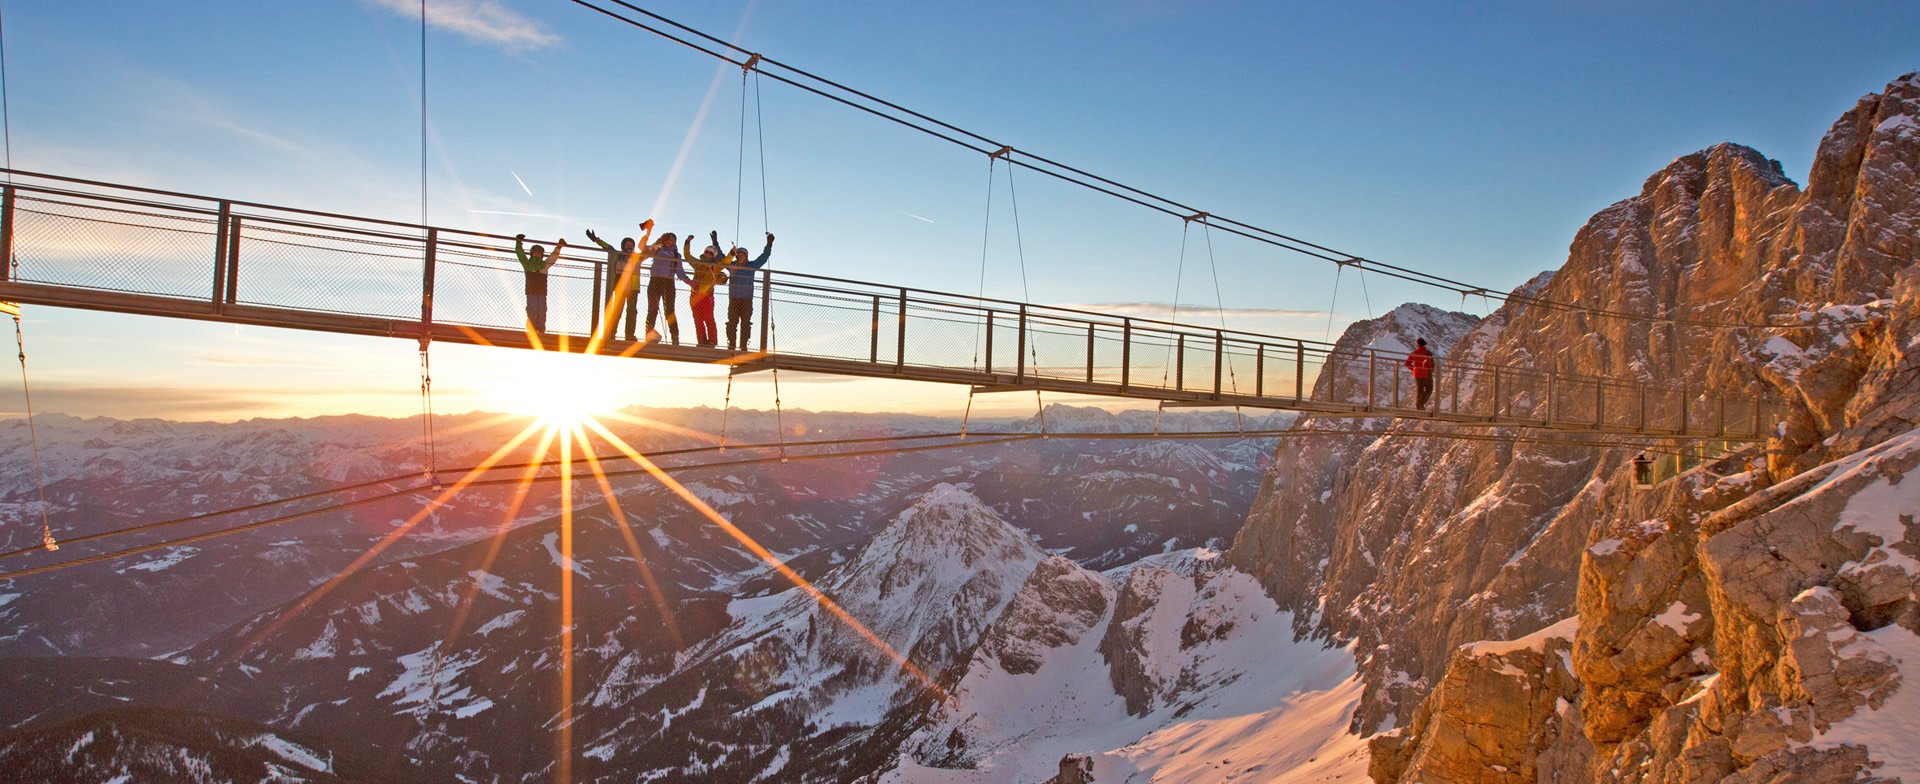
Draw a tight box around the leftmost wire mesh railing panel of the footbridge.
[13,196,217,300]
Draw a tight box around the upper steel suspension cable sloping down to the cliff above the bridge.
[570,0,1858,329]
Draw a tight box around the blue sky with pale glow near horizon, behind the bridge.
[0,0,1920,419]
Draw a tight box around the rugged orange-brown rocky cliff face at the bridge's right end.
[1231,75,1920,782]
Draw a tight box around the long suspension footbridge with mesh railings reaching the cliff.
[0,171,1776,440]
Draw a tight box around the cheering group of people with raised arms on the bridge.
[513,219,774,352]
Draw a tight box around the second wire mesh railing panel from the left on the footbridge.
[230,217,426,319]
